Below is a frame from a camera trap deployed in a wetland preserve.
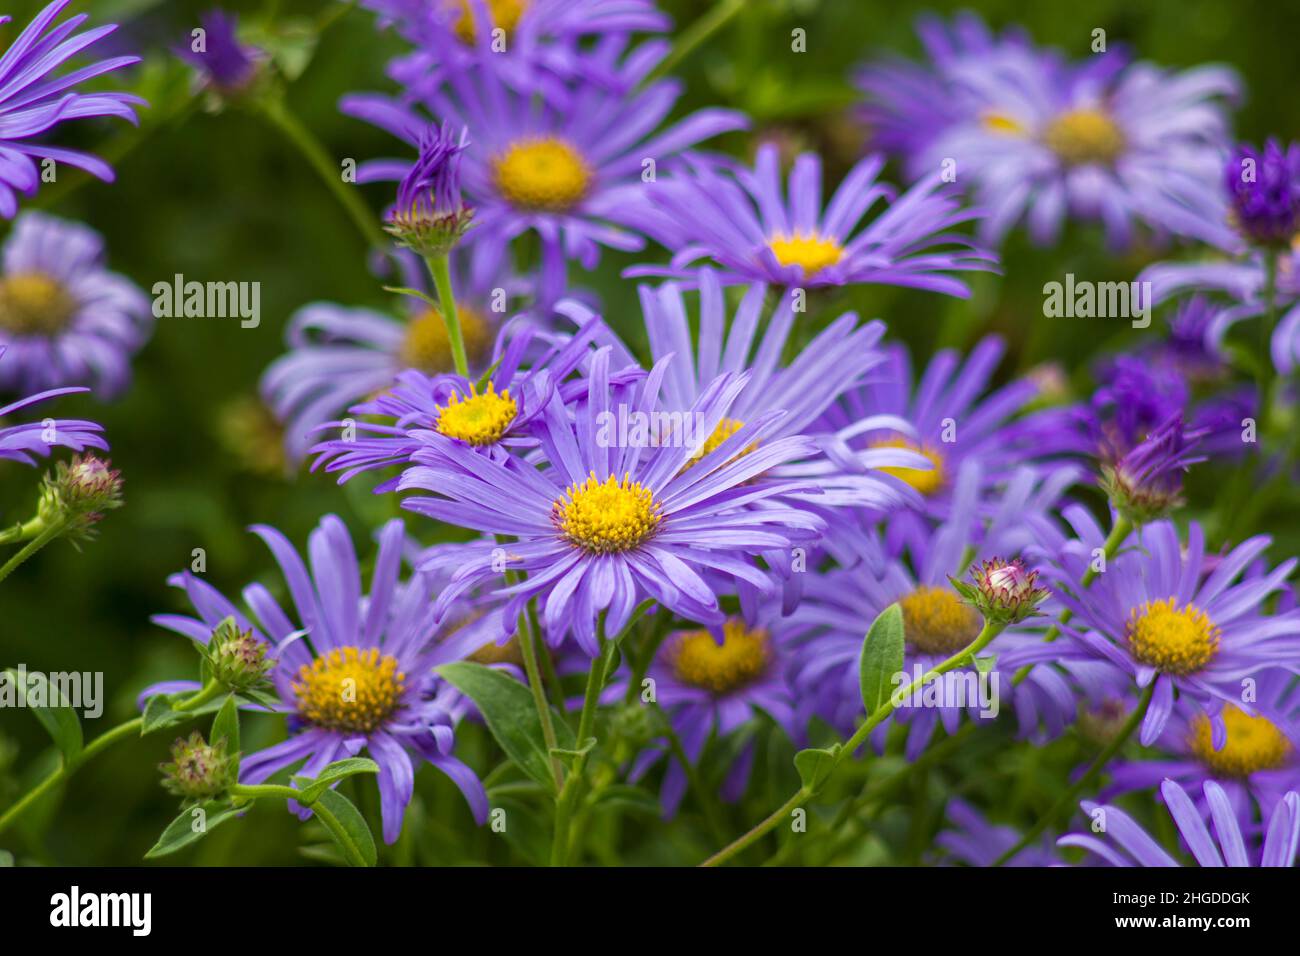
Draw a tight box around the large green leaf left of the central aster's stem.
[438,661,573,788]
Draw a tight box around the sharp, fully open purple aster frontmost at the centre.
[398,349,824,656]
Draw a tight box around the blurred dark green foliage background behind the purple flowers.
[0,0,1300,865]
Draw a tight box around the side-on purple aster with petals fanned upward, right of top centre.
[624,143,997,298]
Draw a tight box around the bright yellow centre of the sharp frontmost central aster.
[551,472,660,554]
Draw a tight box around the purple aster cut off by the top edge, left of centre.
[363,0,671,104]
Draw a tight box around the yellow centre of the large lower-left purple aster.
[294,648,406,734]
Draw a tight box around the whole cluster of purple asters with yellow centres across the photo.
[0,0,1300,865]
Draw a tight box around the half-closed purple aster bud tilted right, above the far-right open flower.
[1101,411,1206,524]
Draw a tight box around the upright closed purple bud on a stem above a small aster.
[387,125,473,256]
